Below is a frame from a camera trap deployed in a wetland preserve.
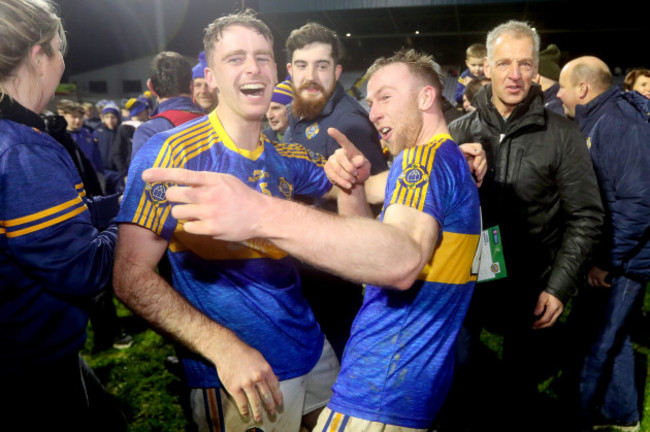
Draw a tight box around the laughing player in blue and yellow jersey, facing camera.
[114,8,339,431]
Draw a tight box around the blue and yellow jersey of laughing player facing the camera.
[118,112,331,387]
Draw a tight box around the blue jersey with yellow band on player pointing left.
[329,135,480,429]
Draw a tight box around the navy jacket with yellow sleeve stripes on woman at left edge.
[0,97,118,372]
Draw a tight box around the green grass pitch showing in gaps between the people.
[82,290,650,432]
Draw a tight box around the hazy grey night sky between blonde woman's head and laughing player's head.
[56,0,234,76]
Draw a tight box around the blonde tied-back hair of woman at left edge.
[0,0,66,99]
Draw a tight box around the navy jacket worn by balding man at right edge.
[576,88,650,280]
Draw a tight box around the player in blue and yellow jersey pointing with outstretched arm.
[143,50,480,432]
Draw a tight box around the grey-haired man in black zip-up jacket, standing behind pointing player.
[449,21,603,430]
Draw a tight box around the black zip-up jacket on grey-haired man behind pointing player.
[449,84,604,304]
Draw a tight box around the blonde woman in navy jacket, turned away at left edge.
[0,0,126,431]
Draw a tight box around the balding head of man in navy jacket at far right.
[557,56,613,117]
